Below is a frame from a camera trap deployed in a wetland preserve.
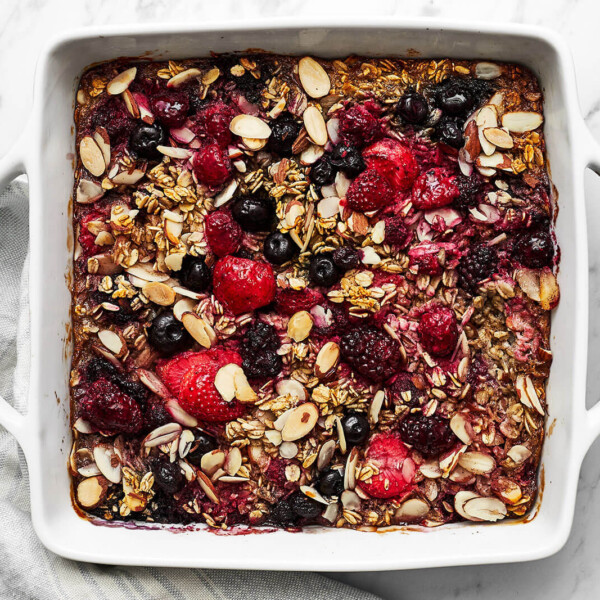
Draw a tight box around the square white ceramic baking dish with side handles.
[0,19,600,571]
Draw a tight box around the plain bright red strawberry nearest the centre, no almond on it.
[213,256,277,315]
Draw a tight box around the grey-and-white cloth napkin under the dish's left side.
[0,182,376,600]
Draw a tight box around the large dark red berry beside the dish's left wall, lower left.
[80,378,142,435]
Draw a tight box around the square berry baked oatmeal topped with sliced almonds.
[69,54,559,529]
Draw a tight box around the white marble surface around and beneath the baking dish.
[0,0,600,600]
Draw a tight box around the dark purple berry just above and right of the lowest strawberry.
[398,413,458,456]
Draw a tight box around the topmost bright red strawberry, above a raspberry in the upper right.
[363,138,419,191]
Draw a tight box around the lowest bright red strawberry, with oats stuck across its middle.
[360,433,415,498]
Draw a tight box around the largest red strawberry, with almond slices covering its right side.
[179,348,246,422]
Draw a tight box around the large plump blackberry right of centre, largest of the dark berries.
[340,326,401,381]
